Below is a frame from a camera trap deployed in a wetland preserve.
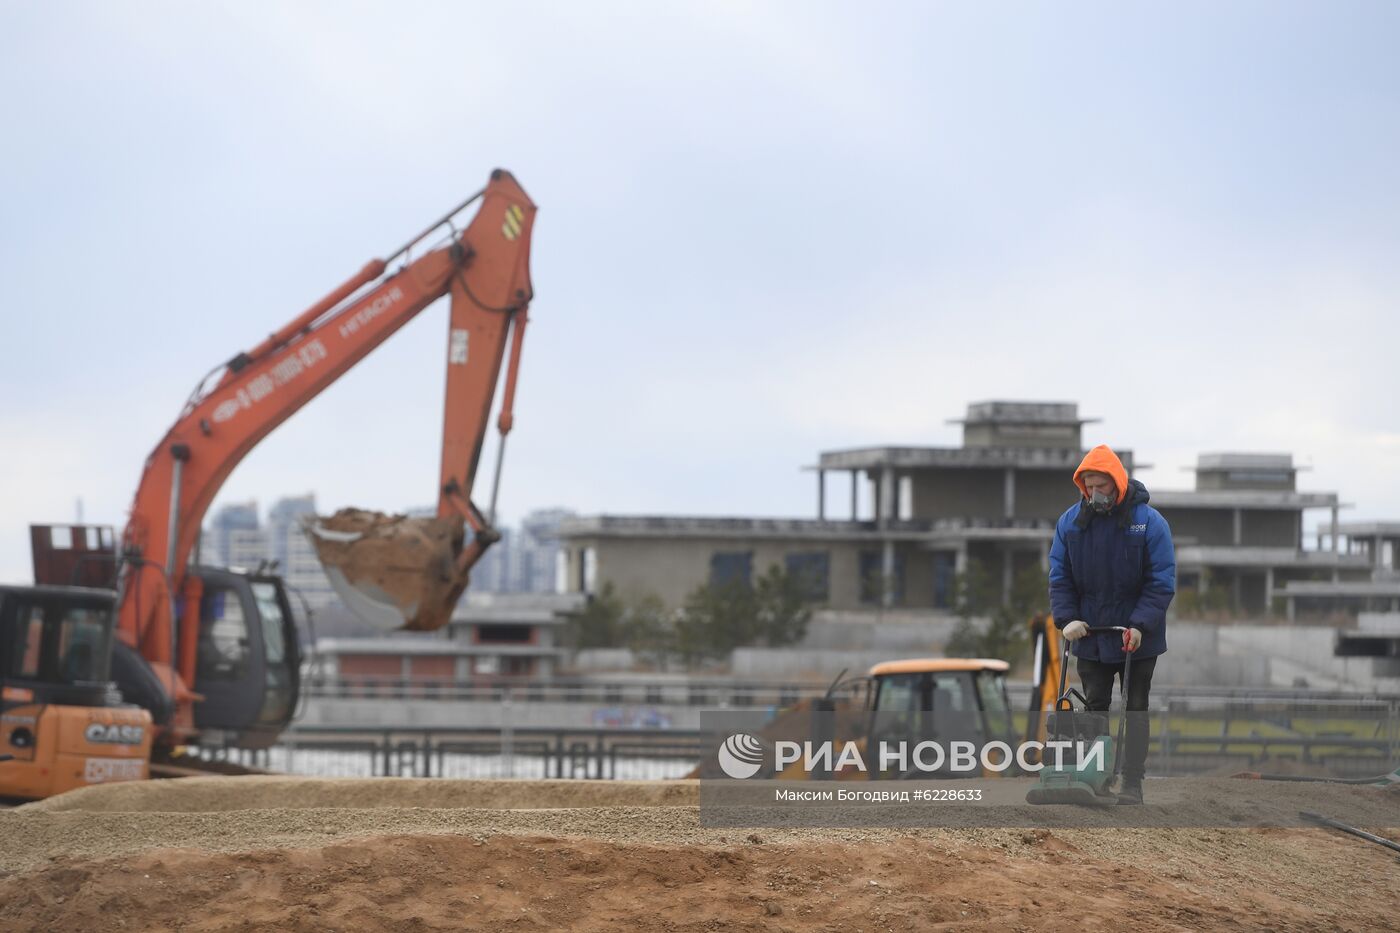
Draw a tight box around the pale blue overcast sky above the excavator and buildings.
[0,0,1400,581]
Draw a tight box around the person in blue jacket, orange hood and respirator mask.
[1050,444,1176,804]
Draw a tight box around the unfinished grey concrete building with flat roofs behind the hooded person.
[560,401,1372,615]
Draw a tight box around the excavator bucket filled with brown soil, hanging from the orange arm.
[304,509,466,632]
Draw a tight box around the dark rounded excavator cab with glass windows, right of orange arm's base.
[190,566,301,748]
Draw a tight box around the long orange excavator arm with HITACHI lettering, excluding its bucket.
[118,170,536,717]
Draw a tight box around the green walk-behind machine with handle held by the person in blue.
[1026,625,1133,807]
